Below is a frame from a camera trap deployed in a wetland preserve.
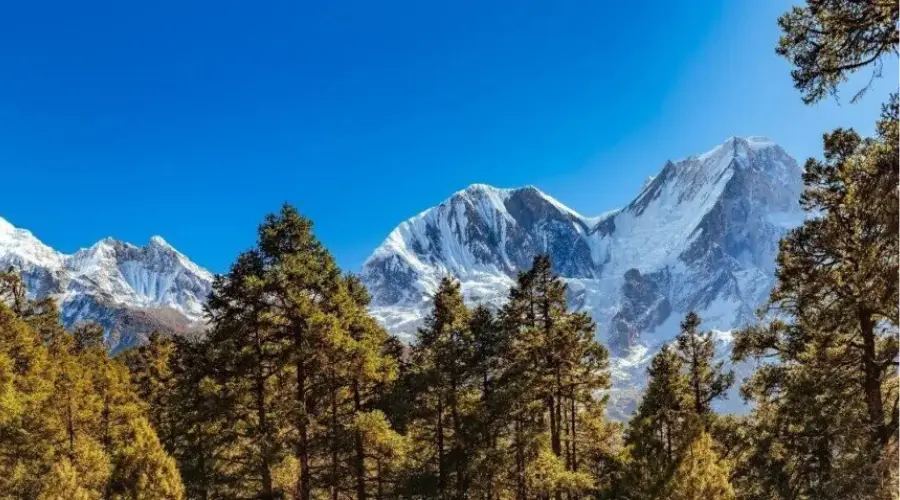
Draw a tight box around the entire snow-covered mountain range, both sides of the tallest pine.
[0,137,804,412]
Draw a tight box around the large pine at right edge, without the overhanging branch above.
[735,98,898,498]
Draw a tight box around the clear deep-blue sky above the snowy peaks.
[0,0,897,272]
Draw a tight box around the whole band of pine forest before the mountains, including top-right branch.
[0,0,900,500]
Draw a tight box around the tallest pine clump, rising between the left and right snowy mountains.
[202,205,395,500]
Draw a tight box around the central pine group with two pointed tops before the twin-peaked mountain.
[374,257,619,499]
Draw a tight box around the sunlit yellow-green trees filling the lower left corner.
[0,273,183,500]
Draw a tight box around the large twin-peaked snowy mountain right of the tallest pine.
[363,137,803,416]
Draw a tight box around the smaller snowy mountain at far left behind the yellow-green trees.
[0,218,212,351]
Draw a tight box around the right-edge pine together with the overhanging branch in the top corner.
[734,0,898,499]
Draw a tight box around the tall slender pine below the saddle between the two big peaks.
[498,256,609,498]
